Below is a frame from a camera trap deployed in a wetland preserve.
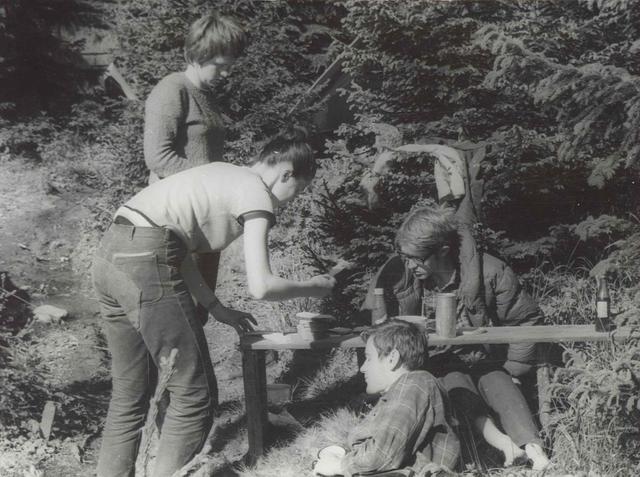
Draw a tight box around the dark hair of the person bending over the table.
[257,126,317,180]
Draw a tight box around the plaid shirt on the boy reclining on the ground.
[342,371,460,477]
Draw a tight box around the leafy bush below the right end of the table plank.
[550,338,640,475]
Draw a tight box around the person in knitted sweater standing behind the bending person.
[144,13,246,321]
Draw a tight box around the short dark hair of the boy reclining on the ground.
[360,320,429,371]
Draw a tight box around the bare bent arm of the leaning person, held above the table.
[244,216,335,301]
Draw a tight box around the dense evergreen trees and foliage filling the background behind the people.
[0,0,640,475]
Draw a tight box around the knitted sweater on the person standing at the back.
[144,73,224,183]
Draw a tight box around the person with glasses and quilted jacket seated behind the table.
[363,206,549,469]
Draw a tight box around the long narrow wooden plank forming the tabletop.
[241,325,640,350]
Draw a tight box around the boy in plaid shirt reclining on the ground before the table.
[314,320,460,476]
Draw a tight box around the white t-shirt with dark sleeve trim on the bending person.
[125,162,276,253]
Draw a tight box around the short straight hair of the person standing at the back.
[184,12,246,65]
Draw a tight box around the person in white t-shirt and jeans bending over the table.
[92,129,335,477]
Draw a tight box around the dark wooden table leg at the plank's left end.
[242,349,268,465]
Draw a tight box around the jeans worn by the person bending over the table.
[92,224,218,477]
